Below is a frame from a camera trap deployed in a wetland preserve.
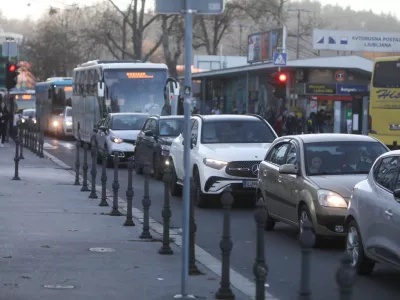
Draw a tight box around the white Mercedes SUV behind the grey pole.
[170,115,277,207]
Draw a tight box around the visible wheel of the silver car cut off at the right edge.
[346,220,375,275]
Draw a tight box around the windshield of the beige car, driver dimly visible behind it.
[304,141,388,176]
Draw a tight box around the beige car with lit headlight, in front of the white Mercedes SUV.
[257,134,389,243]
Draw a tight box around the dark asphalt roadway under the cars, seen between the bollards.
[39,138,400,300]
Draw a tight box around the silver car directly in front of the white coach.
[91,113,148,165]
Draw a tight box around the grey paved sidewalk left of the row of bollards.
[0,142,248,300]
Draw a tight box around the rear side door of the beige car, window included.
[259,141,290,216]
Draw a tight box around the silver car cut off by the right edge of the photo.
[345,150,400,275]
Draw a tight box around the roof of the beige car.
[282,133,378,144]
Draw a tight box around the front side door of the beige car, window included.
[277,140,302,223]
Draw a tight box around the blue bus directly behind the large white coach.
[35,77,72,136]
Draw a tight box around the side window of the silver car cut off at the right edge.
[374,156,399,191]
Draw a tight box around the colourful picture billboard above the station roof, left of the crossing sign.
[247,28,283,63]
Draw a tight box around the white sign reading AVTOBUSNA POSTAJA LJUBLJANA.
[313,29,400,52]
